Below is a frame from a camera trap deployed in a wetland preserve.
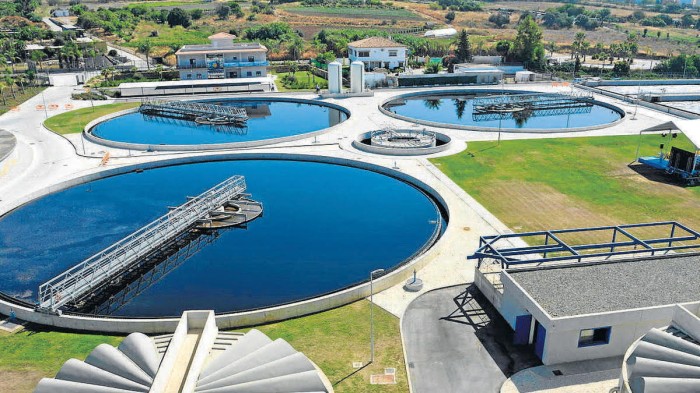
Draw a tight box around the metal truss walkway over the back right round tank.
[472,93,593,121]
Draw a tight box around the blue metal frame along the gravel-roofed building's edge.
[467,221,700,269]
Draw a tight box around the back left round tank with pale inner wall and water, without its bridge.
[85,98,350,150]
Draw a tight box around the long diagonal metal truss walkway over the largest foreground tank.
[37,176,252,312]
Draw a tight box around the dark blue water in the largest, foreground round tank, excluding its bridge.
[0,157,446,317]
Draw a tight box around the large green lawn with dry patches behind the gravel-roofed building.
[431,135,700,239]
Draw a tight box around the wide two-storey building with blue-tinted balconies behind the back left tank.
[175,33,269,80]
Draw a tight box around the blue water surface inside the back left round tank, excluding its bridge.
[92,99,347,145]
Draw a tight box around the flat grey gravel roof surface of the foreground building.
[508,255,700,317]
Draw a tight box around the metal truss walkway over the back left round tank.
[139,101,248,124]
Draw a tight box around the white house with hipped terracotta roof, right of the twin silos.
[348,37,408,71]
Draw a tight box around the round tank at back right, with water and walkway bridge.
[380,89,625,132]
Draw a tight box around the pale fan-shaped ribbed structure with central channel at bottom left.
[34,311,333,393]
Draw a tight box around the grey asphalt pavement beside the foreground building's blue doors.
[401,285,541,393]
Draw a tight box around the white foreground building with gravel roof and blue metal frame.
[475,223,700,366]
